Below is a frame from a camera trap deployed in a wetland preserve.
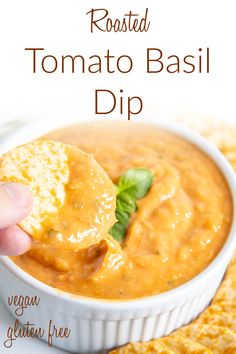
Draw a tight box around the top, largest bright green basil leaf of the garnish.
[117,168,153,199]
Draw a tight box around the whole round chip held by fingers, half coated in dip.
[0,140,116,250]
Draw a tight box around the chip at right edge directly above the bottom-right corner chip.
[195,306,236,332]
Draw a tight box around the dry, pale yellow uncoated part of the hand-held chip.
[0,141,69,238]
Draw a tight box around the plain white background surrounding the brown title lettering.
[0,0,236,354]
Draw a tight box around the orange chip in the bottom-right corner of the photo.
[173,323,236,354]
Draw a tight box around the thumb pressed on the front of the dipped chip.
[0,183,33,229]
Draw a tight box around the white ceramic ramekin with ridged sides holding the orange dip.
[0,120,236,353]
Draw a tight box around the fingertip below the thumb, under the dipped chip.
[0,226,32,256]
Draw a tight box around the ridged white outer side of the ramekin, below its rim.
[0,263,228,353]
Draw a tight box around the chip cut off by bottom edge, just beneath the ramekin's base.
[109,340,175,354]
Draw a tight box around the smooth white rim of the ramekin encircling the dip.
[0,120,236,311]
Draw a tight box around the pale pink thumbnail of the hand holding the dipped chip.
[0,183,32,208]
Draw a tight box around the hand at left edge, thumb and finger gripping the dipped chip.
[0,183,33,256]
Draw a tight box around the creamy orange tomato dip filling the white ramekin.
[12,122,233,300]
